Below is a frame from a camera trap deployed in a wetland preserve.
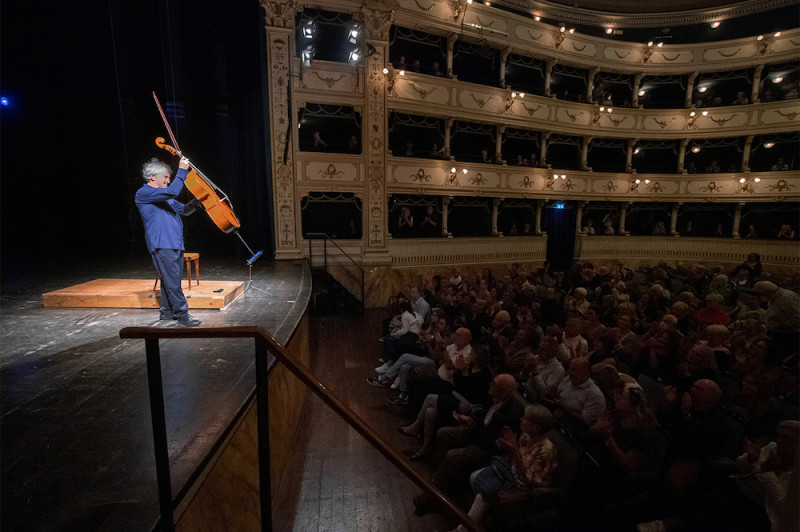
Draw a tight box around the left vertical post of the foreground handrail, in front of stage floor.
[144,338,175,532]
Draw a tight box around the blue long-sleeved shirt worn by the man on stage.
[135,168,194,253]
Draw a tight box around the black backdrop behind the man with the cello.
[0,0,273,262]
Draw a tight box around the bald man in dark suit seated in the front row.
[414,373,523,515]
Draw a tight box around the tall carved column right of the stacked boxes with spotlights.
[362,7,394,264]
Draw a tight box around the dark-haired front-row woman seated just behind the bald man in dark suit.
[397,345,492,460]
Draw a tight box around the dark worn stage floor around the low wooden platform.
[0,256,311,531]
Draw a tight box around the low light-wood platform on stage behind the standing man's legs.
[42,279,244,309]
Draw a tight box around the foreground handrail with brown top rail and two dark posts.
[119,326,483,532]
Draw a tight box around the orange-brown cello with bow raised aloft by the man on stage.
[153,91,262,265]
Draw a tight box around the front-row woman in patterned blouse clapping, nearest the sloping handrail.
[454,405,558,532]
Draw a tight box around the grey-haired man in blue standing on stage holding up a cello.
[135,157,200,327]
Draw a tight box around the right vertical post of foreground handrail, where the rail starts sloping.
[255,338,272,532]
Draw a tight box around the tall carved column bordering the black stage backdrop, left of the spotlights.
[261,0,302,259]
